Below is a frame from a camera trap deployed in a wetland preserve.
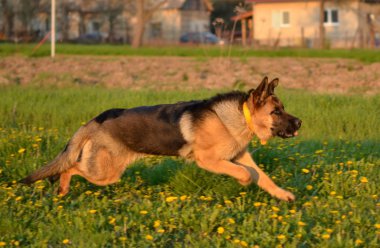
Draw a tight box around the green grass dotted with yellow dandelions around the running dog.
[0,87,380,247]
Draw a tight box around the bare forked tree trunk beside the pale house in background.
[132,0,168,48]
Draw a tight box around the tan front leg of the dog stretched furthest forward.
[234,151,295,201]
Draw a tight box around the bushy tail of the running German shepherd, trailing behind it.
[19,126,89,184]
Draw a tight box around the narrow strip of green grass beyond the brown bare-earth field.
[0,43,380,63]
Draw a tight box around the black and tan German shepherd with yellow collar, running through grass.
[21,77,301,201]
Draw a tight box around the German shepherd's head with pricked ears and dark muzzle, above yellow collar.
[247,77,302,141]
